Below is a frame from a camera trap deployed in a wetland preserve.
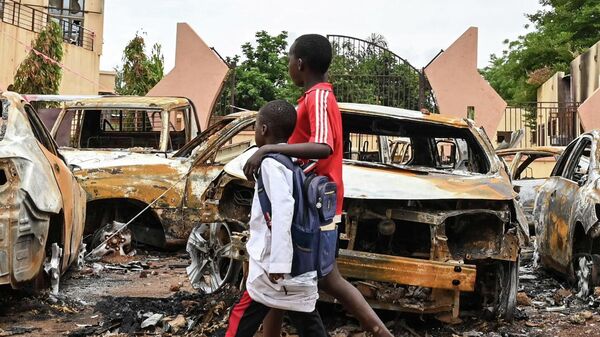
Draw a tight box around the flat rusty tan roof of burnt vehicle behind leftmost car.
[65,96,190,110]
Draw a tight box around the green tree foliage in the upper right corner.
[482,0,600,102]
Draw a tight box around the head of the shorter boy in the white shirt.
[258,99,296,141]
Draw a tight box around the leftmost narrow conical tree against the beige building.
[14,21,63,94]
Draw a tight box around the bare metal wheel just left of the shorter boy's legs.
[186,223,235,294]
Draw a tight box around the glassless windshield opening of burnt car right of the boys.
[343,114,490,174]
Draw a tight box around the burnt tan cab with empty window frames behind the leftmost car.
[51,96,200,156]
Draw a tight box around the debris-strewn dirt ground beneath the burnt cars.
[0,245,600,337]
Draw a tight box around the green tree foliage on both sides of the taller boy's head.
[217,31,426,114]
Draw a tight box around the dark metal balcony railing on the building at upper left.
[0,0,95,50]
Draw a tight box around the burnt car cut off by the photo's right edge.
[534,130,600,296]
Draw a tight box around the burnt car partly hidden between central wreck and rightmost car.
[496,146,564,235]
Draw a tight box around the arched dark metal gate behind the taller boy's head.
[327,35,436,111]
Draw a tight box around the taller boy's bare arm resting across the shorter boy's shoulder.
[244,143,332,180]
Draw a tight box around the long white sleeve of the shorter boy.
[260,158,294,274]
